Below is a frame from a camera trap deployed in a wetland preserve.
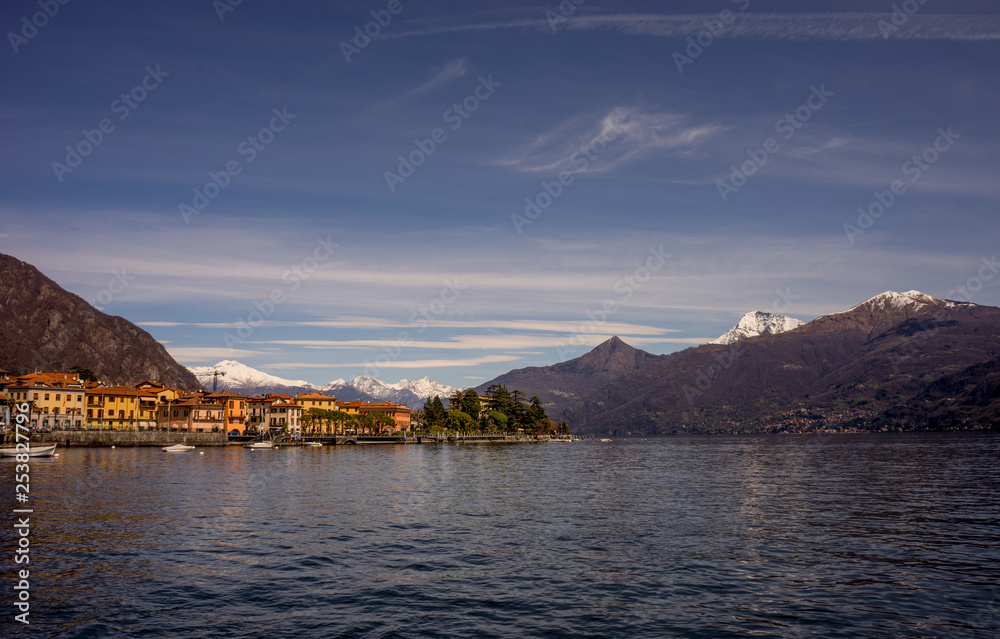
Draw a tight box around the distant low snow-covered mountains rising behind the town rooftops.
[188,360,458,408]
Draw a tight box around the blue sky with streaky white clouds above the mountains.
[0,0,1000,386]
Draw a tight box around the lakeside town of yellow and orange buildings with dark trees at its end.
[0,367,568,440]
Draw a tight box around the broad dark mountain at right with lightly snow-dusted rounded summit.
[556,291,1000,434]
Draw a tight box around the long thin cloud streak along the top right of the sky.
[386,13,1000,42]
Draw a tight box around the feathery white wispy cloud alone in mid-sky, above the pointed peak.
[498,106,724,173]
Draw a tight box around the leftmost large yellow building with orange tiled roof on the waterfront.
[5,373,86,430]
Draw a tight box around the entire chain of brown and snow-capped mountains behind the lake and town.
[0,254,1000,435]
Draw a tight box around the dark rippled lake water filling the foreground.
[0,432,1000,638]
